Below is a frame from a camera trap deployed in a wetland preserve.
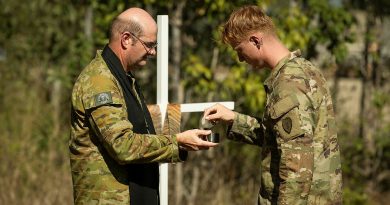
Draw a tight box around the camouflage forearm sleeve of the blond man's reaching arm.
[228,112,263,146]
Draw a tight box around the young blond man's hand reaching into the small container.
[203,103,235,124]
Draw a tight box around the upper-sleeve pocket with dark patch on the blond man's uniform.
[270,96,304,141]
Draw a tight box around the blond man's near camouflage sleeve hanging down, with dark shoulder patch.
[270,83,314,204]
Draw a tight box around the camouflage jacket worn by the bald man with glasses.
[69,51,184,205]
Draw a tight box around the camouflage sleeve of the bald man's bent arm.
[83,76,181,164]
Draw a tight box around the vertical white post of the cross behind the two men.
[157,15,169,205]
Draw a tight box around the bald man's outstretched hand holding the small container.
[176,129,218,151]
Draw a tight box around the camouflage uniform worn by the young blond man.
[229,51,342,205]
